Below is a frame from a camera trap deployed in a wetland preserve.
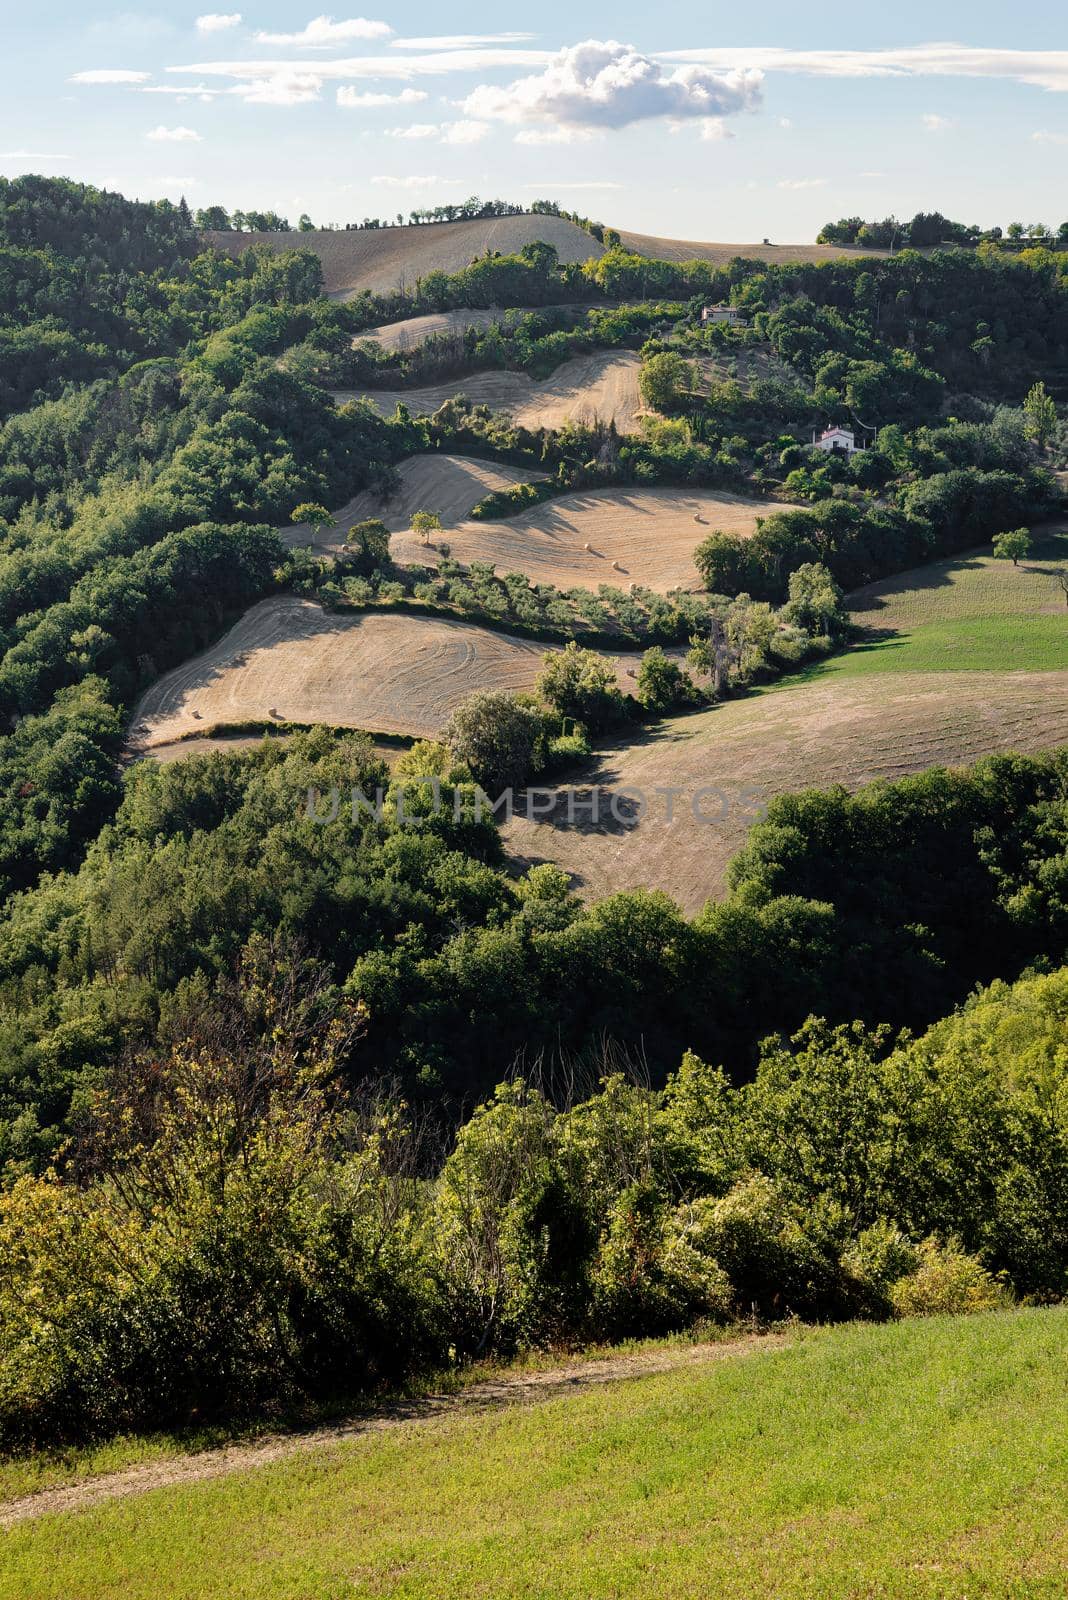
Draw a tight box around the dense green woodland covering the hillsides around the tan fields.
[0,178,1068,1448]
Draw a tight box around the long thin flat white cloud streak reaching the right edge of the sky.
[660,43,1068,91]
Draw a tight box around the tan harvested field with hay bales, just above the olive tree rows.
[283,456,777,592]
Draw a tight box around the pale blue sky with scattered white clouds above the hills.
[0,0,1068,243]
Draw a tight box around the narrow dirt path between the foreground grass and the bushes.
[0,1334,770,1528]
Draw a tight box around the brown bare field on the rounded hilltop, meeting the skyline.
[205,216,604,299]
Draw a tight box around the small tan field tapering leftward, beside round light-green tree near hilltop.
[333,350,641,434]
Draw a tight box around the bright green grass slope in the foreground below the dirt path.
[0,1310,1068,1600]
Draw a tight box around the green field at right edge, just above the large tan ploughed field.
[791,530,1068,683]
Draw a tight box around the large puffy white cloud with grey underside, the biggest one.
[464,38,761,128]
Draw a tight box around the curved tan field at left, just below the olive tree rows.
[128,595,636,755]
